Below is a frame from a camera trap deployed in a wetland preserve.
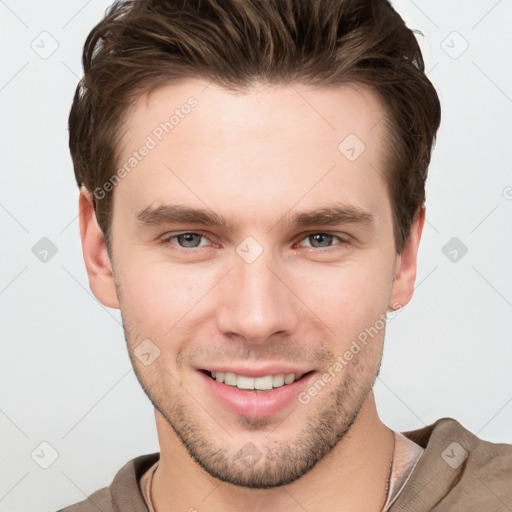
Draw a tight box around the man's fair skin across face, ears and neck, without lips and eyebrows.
[80,80,424,512]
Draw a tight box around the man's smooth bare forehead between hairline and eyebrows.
[114,80,387,228]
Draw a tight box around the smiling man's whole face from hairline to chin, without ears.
[101,81,408,487]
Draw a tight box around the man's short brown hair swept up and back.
[69,0,441,252]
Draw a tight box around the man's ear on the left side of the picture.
[78,187,119,309]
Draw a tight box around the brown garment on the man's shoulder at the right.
[392,418,512,512]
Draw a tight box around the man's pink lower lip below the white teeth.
[198,371,315,418]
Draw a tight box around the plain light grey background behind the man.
[0,0,512,512]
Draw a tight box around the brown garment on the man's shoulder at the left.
[58,452,160,512]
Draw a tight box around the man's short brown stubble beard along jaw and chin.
[125,333,382,489]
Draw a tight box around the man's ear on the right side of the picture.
[389,206,425,310]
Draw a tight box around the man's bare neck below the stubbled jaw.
[152,392,394,512]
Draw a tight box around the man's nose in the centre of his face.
[216,252,300,344]
